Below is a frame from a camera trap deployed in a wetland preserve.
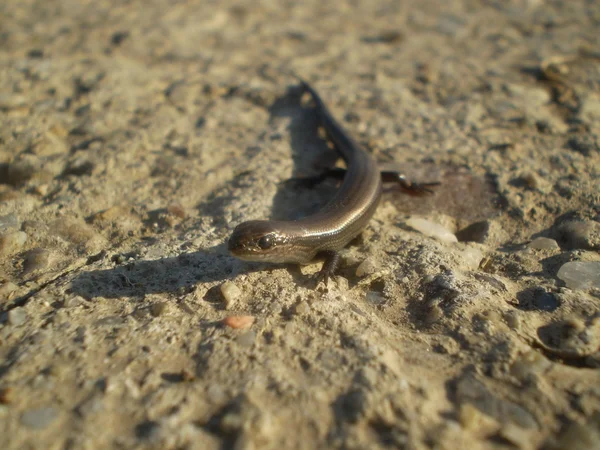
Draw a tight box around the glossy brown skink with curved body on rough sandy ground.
[228,81,437,281]
